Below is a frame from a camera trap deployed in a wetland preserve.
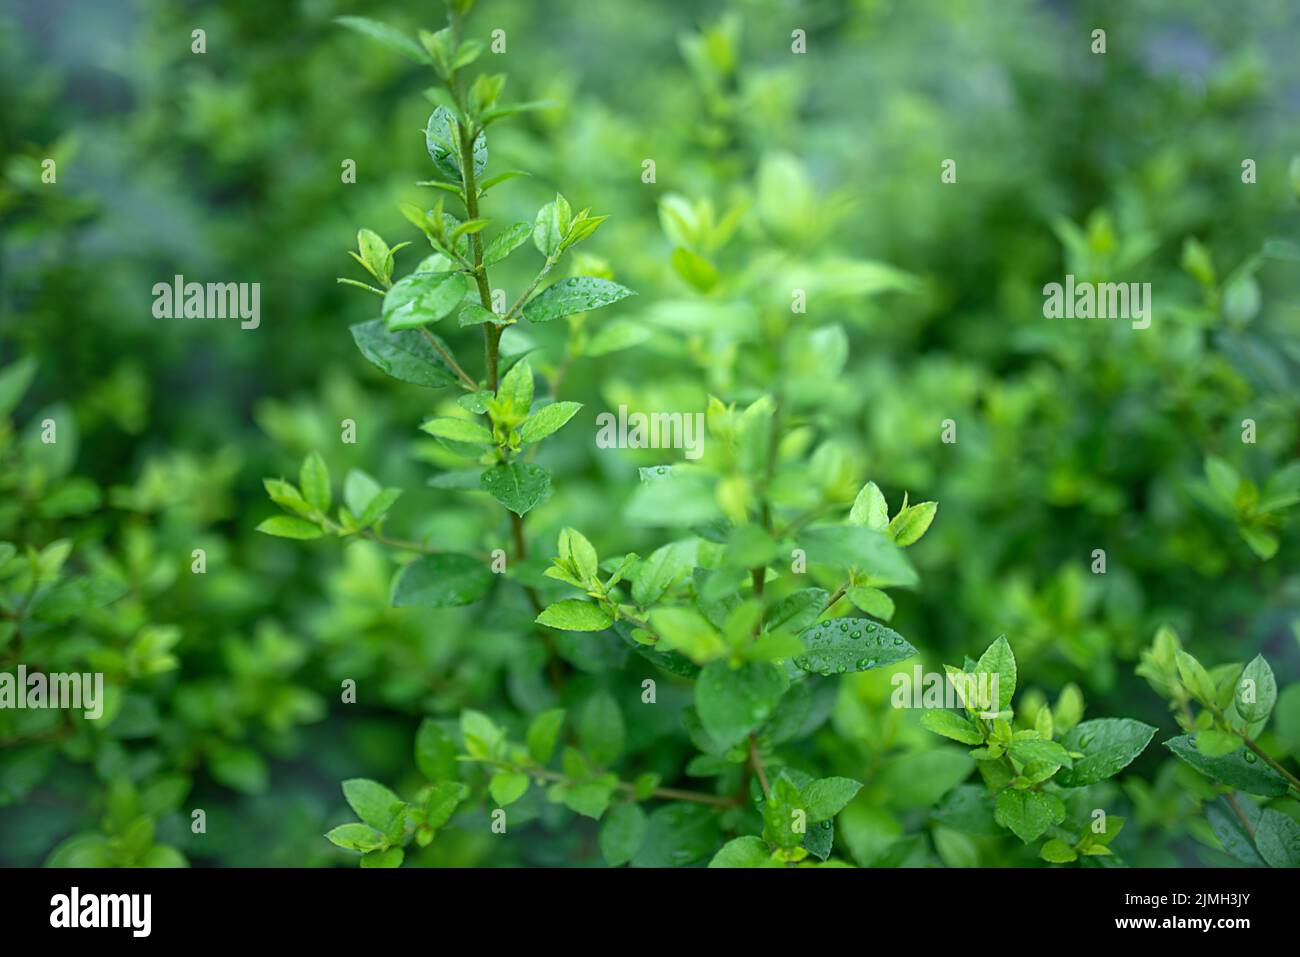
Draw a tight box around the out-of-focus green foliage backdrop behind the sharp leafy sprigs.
[0,0,1300,866]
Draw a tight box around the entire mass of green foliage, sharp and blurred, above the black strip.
[0,0,1300,867]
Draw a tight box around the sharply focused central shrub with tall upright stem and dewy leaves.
[259,4,956,866]
